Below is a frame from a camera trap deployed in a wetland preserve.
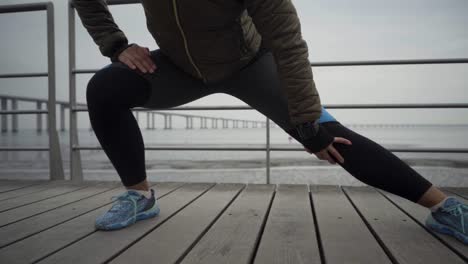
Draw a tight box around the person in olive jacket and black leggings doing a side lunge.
[72,0,468,243]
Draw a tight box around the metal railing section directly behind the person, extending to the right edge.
[69,0,468,183]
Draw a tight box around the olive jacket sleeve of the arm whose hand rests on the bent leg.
[72,0,128,59]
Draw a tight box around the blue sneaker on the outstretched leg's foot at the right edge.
[426,196,468,245]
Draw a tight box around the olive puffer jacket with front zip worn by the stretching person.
[72,0,321,127]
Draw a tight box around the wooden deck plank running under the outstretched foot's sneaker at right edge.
[381,191,468,263]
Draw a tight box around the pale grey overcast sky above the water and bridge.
[0,0,468,128]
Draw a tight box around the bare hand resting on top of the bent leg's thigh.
[118,44,156,73]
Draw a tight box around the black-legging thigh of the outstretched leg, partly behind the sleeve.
[219,49,338,131]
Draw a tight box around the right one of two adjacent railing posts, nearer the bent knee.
[68,0,82,182]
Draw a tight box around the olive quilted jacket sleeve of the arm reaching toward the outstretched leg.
[244,0,322,126]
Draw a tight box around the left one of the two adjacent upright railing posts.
[47,2,65,180]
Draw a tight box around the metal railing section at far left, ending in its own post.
[0,2,64,180]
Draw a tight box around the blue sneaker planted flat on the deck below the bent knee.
[95,189,160,230]
